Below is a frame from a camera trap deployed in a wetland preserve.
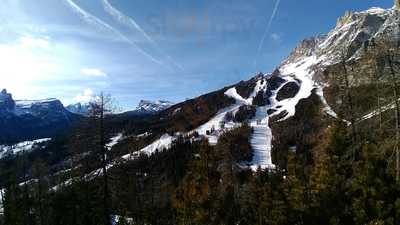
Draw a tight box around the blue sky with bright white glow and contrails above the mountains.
[0,0,393,109]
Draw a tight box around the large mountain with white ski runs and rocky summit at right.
[101,4,400,169]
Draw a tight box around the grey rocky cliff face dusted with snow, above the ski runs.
[280,5,400,92]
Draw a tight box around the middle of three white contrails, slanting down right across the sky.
[102,0,184,70]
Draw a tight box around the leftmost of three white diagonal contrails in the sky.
[65,0,165,66]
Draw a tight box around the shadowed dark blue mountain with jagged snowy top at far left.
[0,90,78,142]
